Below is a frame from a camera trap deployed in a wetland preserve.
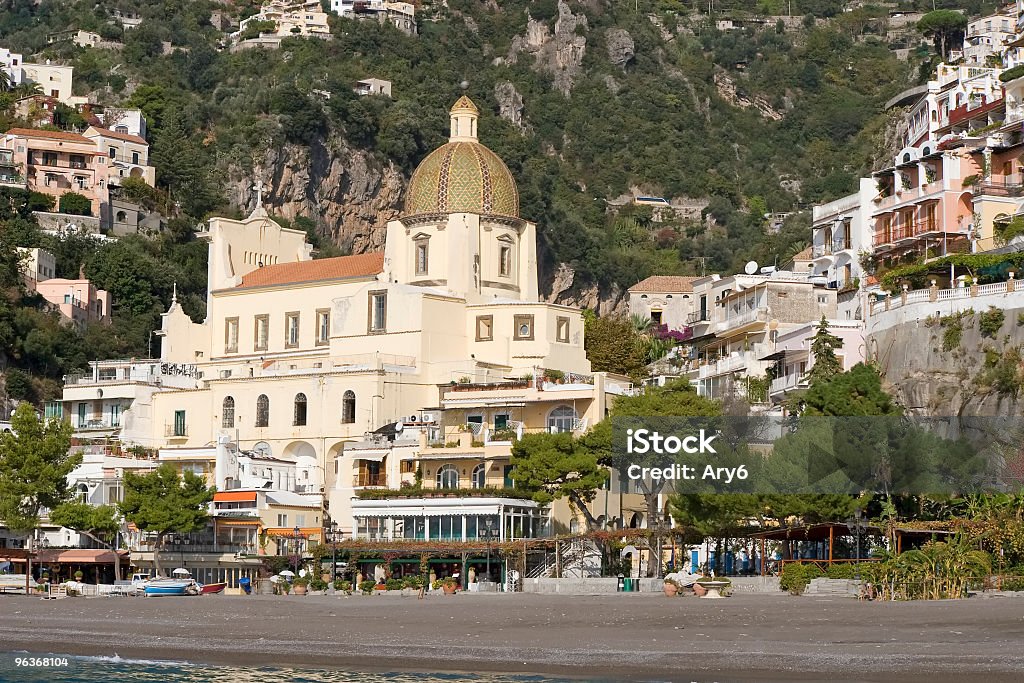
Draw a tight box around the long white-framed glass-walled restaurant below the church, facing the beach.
[352,499,551,542]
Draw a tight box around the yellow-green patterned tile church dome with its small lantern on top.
[406,95,519,218]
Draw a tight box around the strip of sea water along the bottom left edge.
[0,652,610,683]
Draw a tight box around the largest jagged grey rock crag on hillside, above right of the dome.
[505,0,589,95]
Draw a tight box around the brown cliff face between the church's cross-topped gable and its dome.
[227,135,406,254]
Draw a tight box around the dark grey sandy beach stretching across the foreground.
[0,594,1024,683]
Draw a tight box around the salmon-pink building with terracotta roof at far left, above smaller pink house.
[0,128,110,216]
